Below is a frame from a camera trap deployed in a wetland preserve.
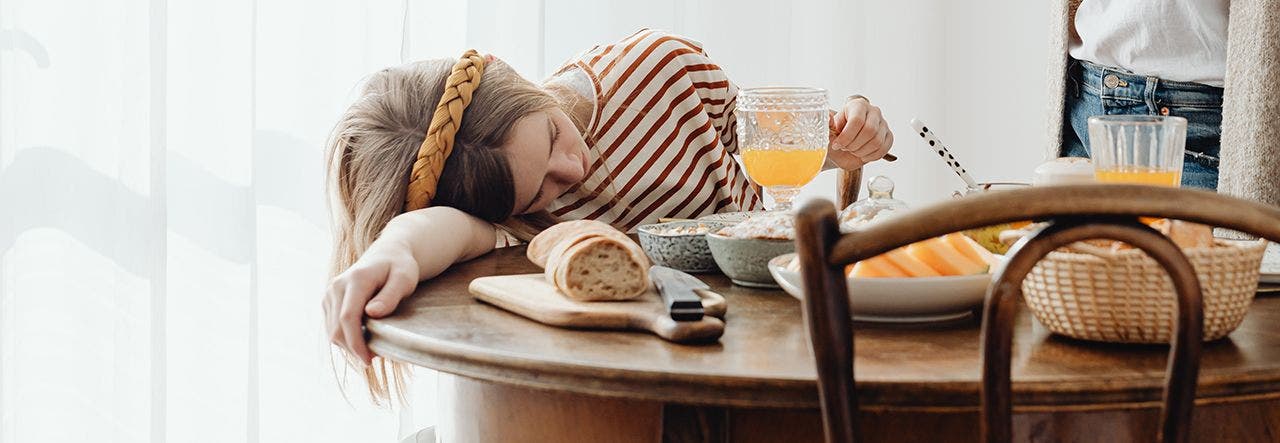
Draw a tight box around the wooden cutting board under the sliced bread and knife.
[468,274,727,342]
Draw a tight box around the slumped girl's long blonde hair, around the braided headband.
[325,59,557,403]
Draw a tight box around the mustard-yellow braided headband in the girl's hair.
[404,49,484,211]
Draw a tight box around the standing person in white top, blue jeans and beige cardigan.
[1048,0,1280,205]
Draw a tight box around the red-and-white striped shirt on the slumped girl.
[548,29,763,232]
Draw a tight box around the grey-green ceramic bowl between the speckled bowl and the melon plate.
[707,233,796,288]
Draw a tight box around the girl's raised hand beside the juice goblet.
[827,97,893,170]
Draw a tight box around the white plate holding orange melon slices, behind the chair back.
[769,254,992,323]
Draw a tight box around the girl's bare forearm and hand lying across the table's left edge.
[324,206,497,364]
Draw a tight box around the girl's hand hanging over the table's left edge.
[324,241,419,365]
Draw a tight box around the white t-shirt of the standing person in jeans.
[1070,0,1230,87]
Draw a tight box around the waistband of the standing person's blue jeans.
[1070,59,1222,108]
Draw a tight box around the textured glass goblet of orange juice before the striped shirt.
[737,87,829,211]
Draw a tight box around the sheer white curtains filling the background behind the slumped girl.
[0,0,1046,443]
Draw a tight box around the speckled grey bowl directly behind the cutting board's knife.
[636,220,726,273]
